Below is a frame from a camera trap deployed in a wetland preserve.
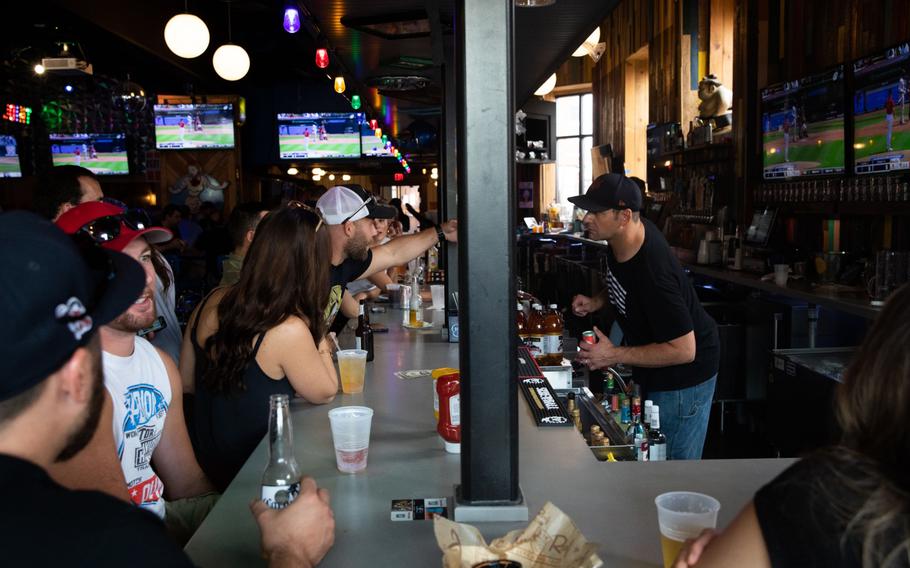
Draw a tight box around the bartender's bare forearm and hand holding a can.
[577,327,695,369]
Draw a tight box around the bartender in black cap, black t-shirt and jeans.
[569,174,720,459]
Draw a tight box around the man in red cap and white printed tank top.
[57,202,217,541]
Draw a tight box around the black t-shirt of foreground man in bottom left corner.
[0,455,192,568]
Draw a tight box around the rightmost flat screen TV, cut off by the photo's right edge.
[853,43,910,175]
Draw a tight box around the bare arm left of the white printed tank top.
[49,389,130,503]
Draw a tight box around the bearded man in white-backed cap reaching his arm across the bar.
[316,184,458,327]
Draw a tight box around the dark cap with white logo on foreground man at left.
[0,211,145,400]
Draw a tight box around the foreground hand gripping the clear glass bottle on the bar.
[250,477,335,568]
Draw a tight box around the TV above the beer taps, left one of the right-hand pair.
[761,65,845,180]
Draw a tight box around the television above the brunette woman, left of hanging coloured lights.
[278,112,363,160]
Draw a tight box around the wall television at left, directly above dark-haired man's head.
[50,134,130,175]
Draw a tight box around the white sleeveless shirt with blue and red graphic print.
[104,337,171,519]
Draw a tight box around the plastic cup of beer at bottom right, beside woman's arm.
[654,491,720,568]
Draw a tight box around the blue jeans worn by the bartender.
[648,374,717,460]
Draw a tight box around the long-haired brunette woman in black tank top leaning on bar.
[180,202,338,491]
